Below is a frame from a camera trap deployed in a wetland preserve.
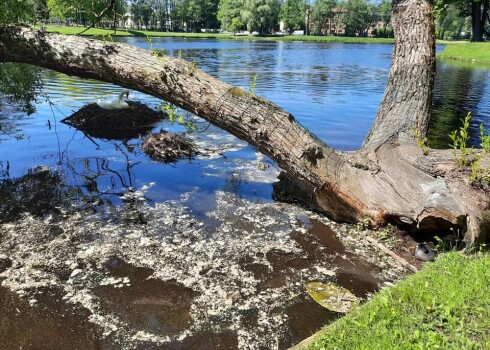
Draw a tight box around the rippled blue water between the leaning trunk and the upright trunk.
[117,38,392,150]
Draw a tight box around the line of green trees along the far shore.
[0,0,490,41]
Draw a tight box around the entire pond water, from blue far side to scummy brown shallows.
[0,38,490,349]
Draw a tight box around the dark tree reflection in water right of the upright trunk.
[428,64,488,148]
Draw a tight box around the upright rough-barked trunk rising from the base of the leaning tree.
[363,0,435,148]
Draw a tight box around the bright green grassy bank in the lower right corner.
[308,252,490,350]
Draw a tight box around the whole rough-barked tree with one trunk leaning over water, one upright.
[0,0,490,244]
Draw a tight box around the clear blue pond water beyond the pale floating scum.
[0,38,490,211]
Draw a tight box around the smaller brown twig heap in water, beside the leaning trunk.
[142,131,196,163]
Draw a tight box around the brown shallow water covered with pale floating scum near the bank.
[0,182,402,349]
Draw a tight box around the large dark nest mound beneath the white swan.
[62,101,165,140]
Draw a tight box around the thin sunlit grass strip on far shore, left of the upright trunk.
[42,26,393,44]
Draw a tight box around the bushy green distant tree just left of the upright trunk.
[340,0,376,36]
